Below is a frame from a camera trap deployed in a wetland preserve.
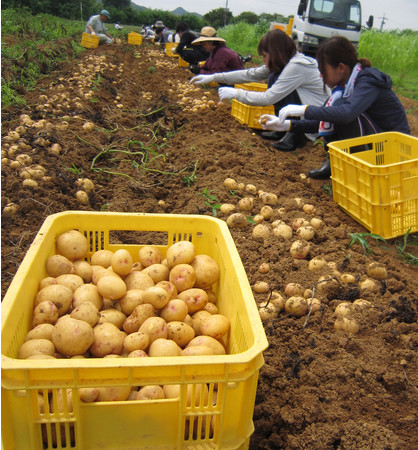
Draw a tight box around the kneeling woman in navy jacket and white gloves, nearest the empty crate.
[260,36,410,179]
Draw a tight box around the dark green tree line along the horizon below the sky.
[1,0,288,30]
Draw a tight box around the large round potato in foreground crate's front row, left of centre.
[52,317,94,356]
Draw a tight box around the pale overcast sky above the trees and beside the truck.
[133,0,418,30]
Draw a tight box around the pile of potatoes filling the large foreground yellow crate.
[18,230,230,401]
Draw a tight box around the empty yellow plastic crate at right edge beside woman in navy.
[328,132,418,239]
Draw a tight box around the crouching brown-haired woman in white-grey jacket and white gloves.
[190,30,329,151]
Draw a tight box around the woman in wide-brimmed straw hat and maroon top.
[190,27,244,74]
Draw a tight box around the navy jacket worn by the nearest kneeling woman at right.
[292,67,411,134]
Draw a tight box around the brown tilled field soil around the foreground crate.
[1,43,418,450]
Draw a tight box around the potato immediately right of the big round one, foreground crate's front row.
[89,322,126,358]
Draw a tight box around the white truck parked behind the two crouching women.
[292,0,373,56]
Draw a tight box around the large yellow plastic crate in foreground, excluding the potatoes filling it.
[1,211,268,450]
